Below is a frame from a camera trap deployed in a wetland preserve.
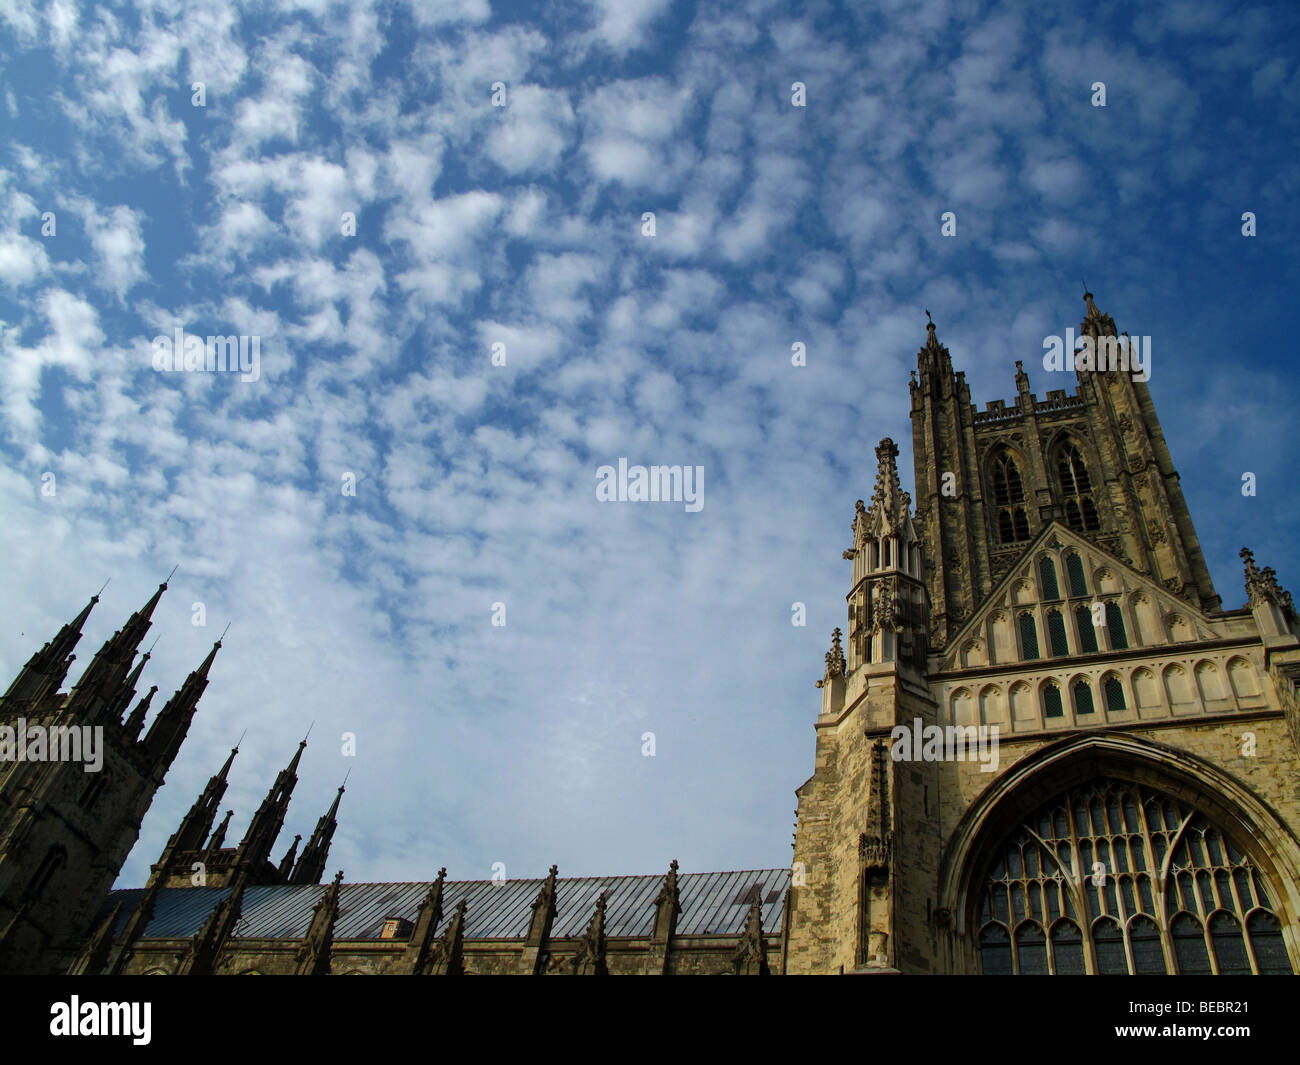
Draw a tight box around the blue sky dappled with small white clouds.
[0,0,1300,886]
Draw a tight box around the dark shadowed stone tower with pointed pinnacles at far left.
[0,583,221,973]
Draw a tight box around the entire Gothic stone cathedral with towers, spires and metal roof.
[0,293,1300,975]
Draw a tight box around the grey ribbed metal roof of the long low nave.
[96,869,790,939]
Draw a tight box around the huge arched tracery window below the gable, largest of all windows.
[975,779,1294,975]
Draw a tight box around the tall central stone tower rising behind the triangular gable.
[911,293,1219,649]
